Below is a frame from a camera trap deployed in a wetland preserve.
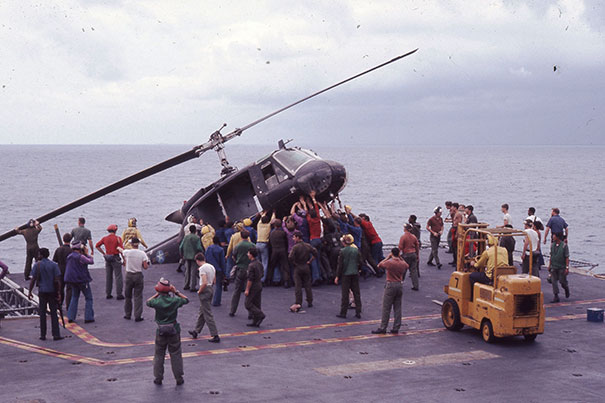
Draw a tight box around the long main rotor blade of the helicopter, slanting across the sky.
[0,49,418,242]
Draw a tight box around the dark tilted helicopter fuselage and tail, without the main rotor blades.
[146,140,347,263]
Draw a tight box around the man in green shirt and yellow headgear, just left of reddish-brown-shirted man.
[334,234,361,319]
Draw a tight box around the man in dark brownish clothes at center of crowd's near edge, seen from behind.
[288,231,317,308]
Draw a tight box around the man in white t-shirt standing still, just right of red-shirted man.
[119,237,149,322]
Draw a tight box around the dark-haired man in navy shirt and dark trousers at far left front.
[28,248,63,340]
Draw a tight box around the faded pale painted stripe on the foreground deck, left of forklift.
[314,350,500,376]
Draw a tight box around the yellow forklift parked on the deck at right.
[441,223,544,343]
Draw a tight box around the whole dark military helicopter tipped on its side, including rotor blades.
[0,49,418,263]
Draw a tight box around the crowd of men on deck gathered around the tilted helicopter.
[0,200,569,384]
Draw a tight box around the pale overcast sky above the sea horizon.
[0,0,605,144]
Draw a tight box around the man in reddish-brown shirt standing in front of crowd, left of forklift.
[372,248,409,334]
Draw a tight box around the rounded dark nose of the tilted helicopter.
[296,160,347,195]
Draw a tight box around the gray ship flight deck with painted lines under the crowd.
[0,250,605,402]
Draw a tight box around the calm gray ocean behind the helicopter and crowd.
[0,142,605,273]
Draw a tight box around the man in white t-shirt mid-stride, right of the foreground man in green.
[189,252,221,343]
